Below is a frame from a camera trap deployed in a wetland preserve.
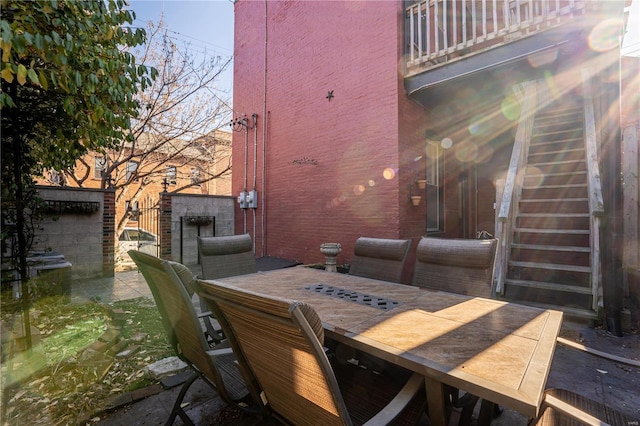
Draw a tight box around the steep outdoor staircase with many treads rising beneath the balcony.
[500,80,599,319]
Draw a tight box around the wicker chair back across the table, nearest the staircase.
[413,237,498,297]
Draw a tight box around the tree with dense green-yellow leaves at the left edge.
[0,0,156,348]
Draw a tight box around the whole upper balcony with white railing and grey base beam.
[405,0,595,101]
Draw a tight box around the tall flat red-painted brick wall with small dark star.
[233,1,408,263]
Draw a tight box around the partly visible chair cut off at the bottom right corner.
[530,389,639,426]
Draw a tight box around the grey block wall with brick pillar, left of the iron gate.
[31,187,114,277]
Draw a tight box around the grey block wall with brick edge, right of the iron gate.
[161,193,235,265]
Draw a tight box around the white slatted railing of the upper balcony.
[405,0,585,73]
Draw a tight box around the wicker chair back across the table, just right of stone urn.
[349,237,411,283]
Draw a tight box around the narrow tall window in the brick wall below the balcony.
[425,141,444,232]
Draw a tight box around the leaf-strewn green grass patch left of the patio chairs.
[0,294,173,425]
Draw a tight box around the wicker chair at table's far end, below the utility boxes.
[198,234,256,343]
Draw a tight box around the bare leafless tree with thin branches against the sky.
[64,19,232,240]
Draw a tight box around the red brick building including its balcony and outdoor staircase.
[232,0,637,328]
